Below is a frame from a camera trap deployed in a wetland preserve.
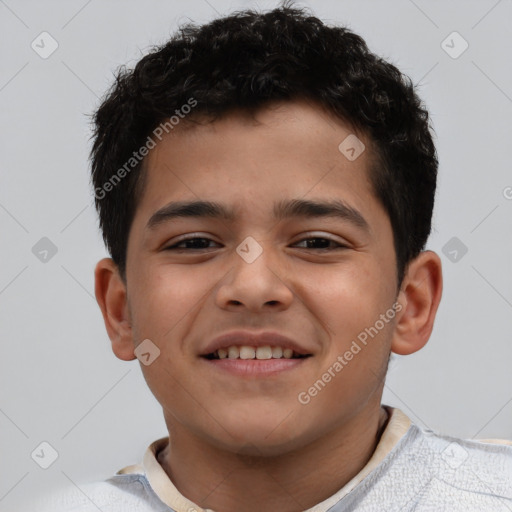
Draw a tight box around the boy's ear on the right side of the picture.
[391,251,443,355]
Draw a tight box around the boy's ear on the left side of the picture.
[94,258,136,361]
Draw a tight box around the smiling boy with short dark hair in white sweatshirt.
[42,4,512,512]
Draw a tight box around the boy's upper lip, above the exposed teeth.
[201,331,310,356]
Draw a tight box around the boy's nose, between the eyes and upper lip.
[216,239,294,313]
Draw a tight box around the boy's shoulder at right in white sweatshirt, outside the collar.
[333,424,512,512]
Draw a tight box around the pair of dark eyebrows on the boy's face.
[146,199,370,232]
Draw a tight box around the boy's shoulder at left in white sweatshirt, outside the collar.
[34,474,172,512]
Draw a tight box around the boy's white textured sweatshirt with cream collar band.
[33,406,512,512]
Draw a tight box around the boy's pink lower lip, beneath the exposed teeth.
[202,356,311,377]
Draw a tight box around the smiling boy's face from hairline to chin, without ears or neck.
[126,102,397,454]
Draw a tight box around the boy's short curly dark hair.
[91,2,438,286]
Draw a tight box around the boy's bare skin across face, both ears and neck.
[95,101,442,512]
